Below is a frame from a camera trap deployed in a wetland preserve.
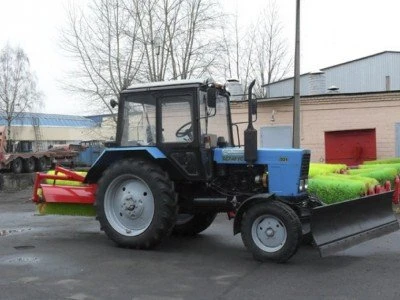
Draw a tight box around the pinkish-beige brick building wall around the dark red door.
[232,92,400,162]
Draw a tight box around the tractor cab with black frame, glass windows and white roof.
[117,80,233,181]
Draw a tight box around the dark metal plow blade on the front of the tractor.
[311,191,399,257]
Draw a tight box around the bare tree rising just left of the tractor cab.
[61,0,143,117]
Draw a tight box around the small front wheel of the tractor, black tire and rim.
[241,201,302,263]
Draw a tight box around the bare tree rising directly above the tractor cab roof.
[130,0,219,81]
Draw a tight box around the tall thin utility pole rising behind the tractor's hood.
[292,0,300,148]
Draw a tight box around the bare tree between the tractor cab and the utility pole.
[222,1,292,97]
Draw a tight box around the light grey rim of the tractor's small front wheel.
[251,215,287,252]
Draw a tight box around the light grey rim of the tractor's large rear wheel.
[104,175,154,236]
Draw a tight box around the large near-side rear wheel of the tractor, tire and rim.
[96,159,177,249]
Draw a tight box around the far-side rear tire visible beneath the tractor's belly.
[172,212,217,236]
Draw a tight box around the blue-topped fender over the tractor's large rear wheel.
[84,147,166,183]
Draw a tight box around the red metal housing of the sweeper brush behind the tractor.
[32,166,97,204]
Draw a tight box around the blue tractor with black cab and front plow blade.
[85,80,399,262]
